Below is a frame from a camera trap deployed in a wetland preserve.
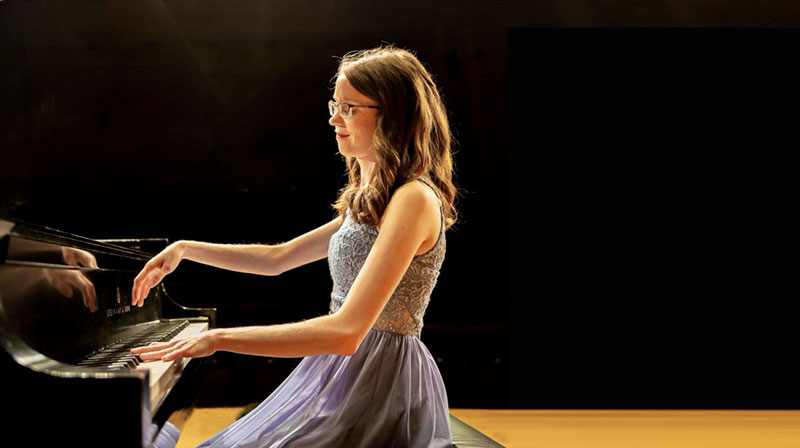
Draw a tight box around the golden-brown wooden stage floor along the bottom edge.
[177,408,800,448]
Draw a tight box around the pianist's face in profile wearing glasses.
[328,74,377,162]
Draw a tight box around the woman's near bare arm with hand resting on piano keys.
[134,182,441,360]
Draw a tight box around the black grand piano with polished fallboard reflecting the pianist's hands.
[0,220,216,448]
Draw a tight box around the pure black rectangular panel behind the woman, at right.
[508,29,800,408]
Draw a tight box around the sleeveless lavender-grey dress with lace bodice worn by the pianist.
[198,179,453,448]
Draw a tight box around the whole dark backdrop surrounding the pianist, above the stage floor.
[0,0,800,408]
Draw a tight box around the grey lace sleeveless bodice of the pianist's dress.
[328,179,446,337]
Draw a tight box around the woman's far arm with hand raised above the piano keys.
[131,217,342,306]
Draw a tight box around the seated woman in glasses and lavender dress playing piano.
[133,46,456,447]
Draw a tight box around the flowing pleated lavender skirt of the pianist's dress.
[198,330,452,448]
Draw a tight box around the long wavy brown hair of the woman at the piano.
[333,45,458,228]
